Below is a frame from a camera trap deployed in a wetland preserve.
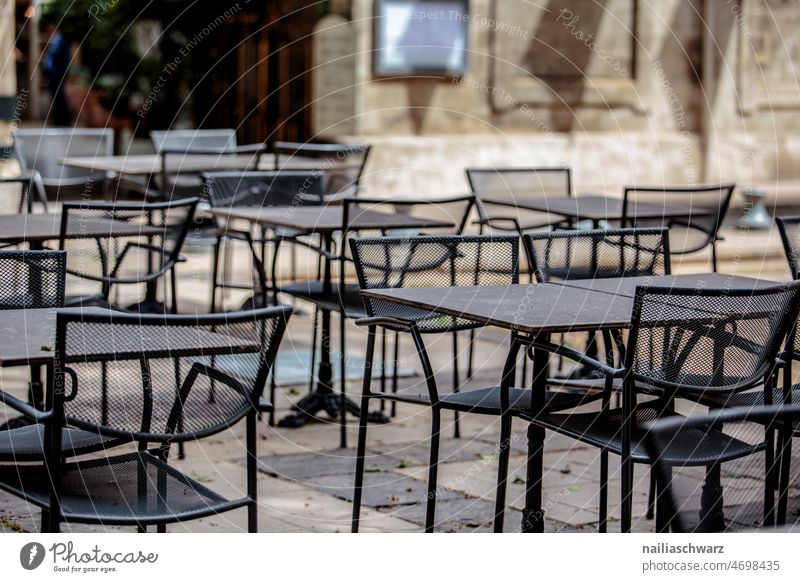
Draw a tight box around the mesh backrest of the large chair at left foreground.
[55,306,292,442]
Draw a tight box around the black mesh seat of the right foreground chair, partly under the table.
[530,405,762,466]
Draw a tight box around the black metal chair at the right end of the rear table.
[622,184,736,272]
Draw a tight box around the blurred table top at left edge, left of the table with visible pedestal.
[0,212,164,243]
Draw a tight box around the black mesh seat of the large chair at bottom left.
[0,452,248,525]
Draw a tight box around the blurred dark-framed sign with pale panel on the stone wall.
[373,0,470,77]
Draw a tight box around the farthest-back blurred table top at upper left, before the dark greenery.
[61,154,346,176]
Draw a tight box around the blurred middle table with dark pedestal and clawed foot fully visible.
[208,204,453,447]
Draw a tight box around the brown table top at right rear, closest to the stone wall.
[481,194,712,221]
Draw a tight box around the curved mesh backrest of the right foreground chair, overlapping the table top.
[626,282,800,395]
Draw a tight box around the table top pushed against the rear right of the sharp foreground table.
[555,273,780,297]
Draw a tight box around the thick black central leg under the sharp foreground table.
[521,335,550,533]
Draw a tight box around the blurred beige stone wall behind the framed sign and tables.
[318,0,800,210]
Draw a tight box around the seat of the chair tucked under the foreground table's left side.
[375,386,602,415]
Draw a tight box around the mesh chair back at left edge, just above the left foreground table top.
[0,250,66,310]
